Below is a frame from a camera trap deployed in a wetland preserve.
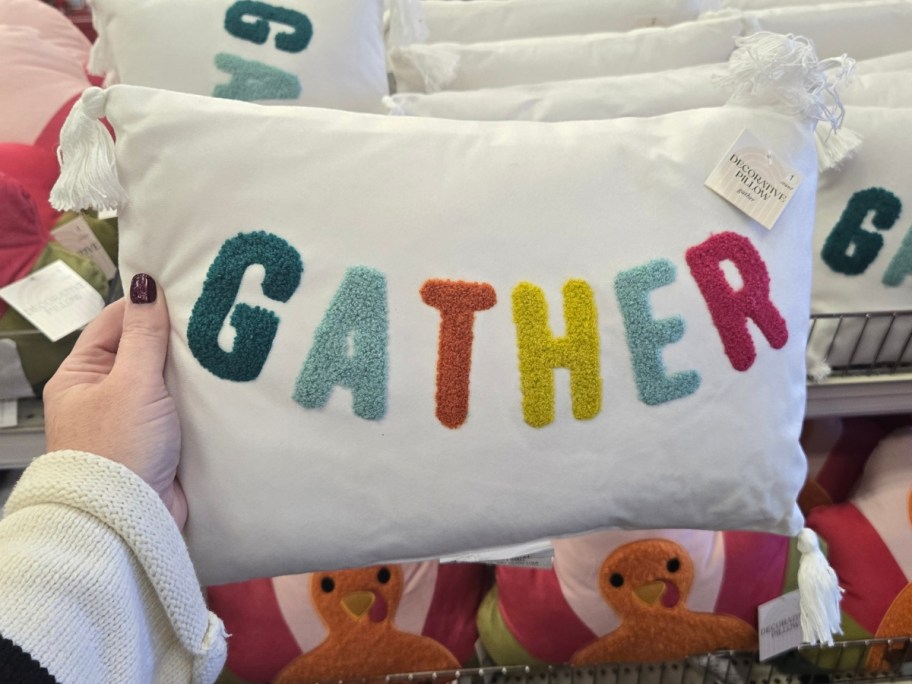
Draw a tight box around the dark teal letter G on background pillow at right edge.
[820,188,902,275]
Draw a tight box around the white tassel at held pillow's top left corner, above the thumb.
[50,88,127,211]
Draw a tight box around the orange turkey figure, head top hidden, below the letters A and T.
[275,565,459,684]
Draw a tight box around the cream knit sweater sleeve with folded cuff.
[0,451,226,684]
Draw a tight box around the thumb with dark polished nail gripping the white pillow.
[112,273,170,379]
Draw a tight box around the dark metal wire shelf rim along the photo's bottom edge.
[312,637,912,684]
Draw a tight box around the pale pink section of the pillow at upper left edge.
[0,25,89,145]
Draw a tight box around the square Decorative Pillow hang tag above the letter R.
[706,129,802,230]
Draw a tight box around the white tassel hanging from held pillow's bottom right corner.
[798,527,843,646]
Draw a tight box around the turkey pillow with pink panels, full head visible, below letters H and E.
[478,530,798,665]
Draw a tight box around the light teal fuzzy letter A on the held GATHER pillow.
[292,266,389,420]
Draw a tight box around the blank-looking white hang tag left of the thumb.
[0,261,104,342]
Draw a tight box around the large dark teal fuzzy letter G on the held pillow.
[187,231,304,382]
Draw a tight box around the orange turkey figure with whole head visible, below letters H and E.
[571,539,757,665]
